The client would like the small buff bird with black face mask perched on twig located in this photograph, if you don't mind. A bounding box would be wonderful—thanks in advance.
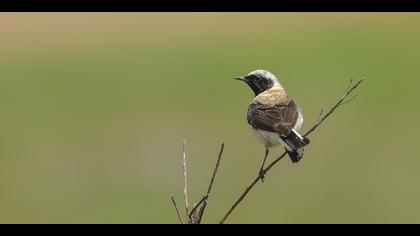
[235,69,310,181]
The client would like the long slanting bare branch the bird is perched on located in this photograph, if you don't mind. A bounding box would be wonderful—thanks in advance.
[219,79,364,224]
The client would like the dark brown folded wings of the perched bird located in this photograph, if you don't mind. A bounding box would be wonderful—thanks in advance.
[247,99,299,137]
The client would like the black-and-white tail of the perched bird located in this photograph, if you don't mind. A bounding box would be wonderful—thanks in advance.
[283,129,310,163]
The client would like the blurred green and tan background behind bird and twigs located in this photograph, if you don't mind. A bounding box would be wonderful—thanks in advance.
[0,13,420,223]
